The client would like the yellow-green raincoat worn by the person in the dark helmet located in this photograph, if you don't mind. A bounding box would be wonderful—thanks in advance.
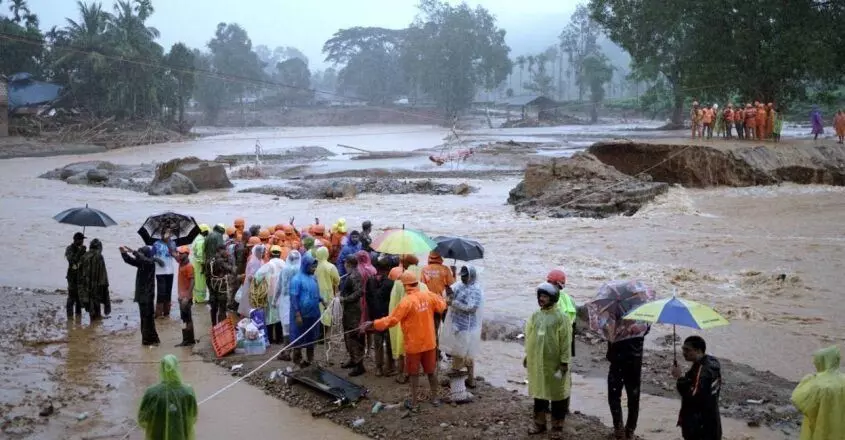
[525,306,572,401]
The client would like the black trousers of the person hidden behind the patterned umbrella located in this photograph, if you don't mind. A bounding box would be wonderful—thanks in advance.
[607,358,643,432]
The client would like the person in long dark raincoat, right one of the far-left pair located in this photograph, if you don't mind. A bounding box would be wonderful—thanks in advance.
[79,238,111,321]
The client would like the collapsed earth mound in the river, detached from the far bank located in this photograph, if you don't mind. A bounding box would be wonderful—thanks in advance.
[508,153,669,218]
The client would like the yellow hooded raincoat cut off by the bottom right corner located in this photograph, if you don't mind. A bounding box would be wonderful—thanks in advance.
[792,346,845,440]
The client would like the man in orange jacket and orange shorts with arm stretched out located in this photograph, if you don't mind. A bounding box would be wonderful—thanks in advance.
[363,271,446,410]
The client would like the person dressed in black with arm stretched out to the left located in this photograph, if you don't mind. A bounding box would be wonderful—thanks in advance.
[121,246,161,345]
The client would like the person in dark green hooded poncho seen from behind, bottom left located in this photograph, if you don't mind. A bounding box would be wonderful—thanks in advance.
[138,354,198,440]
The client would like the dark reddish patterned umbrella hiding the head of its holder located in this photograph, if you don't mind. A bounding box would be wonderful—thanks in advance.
[586,280,654,343]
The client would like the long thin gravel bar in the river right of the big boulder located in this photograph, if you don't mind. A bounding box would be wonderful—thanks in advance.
[239,178,478,200]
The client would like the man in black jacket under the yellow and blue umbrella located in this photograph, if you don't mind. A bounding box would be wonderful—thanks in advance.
[672,336,724,440]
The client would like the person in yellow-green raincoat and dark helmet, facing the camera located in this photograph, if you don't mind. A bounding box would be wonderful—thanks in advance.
[523,283,572,435]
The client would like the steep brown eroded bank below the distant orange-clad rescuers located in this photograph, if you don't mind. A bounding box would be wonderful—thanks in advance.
[587,141,845,188]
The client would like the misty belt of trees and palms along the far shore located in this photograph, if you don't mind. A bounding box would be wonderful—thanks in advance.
[0,0,845,124]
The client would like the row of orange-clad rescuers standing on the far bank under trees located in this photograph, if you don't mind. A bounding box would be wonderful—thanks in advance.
[690,101,783,142]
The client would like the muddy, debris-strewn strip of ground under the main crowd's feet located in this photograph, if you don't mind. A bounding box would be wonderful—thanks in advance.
[195,336,610,440]
